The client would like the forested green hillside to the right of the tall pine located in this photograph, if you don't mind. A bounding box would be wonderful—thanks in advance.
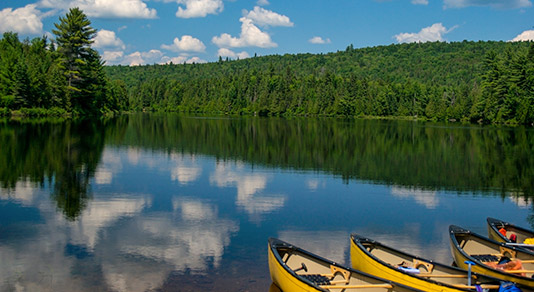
[105,41,534,124]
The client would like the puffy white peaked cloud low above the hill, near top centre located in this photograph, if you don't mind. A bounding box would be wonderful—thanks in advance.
[211,17,278,48]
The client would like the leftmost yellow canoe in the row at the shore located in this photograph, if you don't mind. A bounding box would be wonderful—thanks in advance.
[269,238,422,292]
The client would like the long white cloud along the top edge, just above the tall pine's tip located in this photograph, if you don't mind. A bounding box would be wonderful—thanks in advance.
[39,0,157,18]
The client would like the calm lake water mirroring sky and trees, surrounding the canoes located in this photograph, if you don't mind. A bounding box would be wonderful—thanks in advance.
[0,115,534,291]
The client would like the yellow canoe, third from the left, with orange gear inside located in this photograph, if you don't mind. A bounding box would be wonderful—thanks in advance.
[449,225,534,287]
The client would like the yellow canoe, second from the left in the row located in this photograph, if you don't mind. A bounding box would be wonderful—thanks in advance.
[350,234,506,292]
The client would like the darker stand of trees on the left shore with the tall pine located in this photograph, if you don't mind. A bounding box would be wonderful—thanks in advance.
[0,8,124,116]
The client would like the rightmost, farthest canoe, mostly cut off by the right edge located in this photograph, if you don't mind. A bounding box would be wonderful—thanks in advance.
[486,217,534,249]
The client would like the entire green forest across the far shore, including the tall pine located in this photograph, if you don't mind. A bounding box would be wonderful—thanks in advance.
[0,8,534,125]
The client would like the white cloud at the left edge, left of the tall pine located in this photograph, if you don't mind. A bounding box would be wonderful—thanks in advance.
[0,4,43,34]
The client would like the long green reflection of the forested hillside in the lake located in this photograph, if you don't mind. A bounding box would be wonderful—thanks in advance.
[117,115,534,198]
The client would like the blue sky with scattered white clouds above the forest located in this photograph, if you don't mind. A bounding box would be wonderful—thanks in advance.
[0,0,534,65]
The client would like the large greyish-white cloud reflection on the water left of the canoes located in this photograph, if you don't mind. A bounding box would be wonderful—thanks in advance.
[103,197,239,291]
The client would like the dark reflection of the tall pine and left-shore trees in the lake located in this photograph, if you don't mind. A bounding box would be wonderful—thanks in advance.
[0,117,128,220]
